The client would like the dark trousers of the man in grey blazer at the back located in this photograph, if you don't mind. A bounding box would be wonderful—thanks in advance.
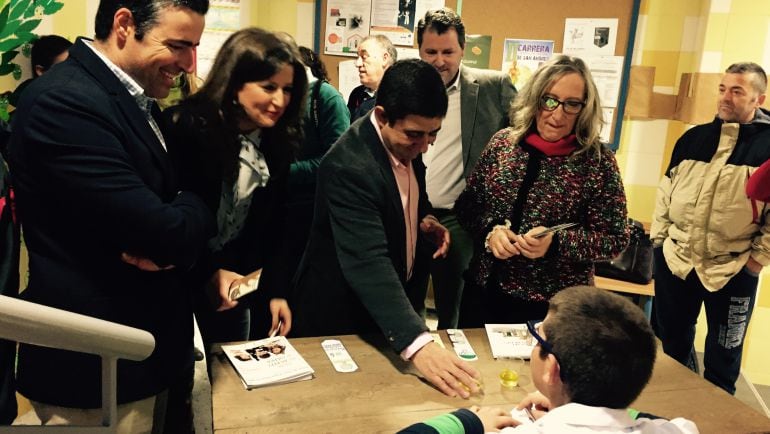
[430,210,473,330]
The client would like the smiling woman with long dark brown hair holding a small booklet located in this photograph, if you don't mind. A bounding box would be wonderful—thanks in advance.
[164,28,307,347]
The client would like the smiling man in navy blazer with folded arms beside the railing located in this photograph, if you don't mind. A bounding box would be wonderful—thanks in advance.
[9,0,214,430]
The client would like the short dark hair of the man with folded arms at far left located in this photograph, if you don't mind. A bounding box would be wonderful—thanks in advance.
[94,0,209,41]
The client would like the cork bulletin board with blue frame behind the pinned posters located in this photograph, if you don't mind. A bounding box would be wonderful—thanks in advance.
[315,0,641,149]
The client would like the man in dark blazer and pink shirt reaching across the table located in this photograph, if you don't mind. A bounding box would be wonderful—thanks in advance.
[292,59,478,397]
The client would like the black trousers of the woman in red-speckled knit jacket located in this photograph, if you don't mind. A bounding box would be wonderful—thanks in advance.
[458,282,548,328]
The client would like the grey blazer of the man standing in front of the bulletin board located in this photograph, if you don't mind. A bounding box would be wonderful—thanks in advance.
[456,66,516,178]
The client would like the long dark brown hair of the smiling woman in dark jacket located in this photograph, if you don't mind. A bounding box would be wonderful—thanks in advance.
[184,27,307,179]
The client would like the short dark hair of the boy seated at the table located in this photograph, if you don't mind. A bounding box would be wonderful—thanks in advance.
[540,286,657,408]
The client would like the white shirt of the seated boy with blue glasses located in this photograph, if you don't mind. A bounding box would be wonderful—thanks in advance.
[500,403,698,434]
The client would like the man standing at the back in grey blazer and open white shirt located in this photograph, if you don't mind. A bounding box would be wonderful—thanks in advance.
[417,8,516,329]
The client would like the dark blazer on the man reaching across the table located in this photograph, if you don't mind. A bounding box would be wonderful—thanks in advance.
[291,116,435,352]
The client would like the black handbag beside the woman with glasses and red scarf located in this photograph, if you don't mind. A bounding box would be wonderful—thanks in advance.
[594,219,652,285]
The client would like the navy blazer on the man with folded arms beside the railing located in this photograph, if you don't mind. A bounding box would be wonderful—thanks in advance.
[9,40,214,408]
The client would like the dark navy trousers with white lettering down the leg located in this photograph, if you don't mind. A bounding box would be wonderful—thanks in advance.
[653,248,758,394]
